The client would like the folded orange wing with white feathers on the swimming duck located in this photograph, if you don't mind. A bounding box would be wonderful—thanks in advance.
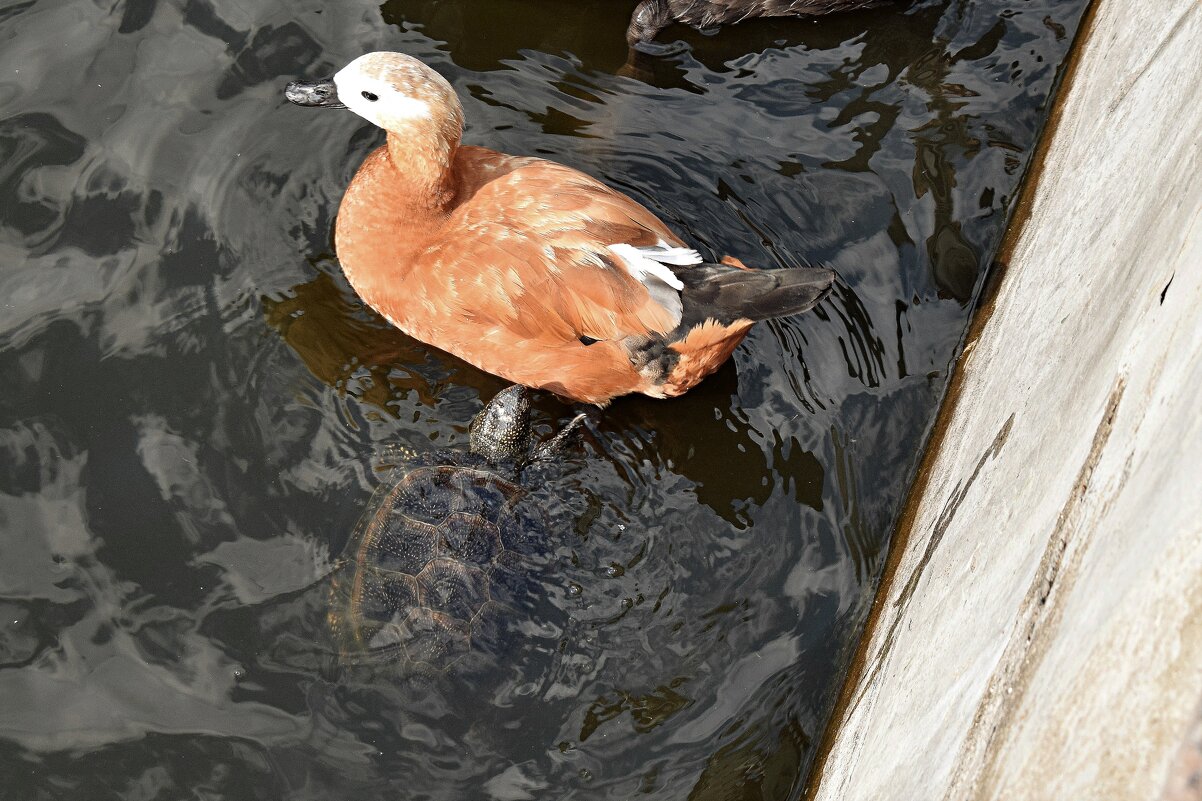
[422,159,701,340]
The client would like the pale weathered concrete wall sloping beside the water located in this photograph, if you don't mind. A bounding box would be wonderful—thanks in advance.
[810,0,1202,801]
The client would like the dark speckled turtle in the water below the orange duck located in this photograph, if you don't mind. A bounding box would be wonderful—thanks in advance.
[329,386,584,671]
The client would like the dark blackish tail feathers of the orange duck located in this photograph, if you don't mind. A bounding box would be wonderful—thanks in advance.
[670,265,835,327]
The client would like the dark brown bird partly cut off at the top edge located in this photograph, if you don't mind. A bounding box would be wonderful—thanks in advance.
[626,0,887,47]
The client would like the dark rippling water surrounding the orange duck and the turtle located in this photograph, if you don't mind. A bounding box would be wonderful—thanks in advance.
[0,0,1084,800]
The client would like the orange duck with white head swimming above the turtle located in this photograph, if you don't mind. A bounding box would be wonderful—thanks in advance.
[287,53,834,404]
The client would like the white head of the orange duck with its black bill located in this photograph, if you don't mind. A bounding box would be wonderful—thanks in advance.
[285,52,463,143]
